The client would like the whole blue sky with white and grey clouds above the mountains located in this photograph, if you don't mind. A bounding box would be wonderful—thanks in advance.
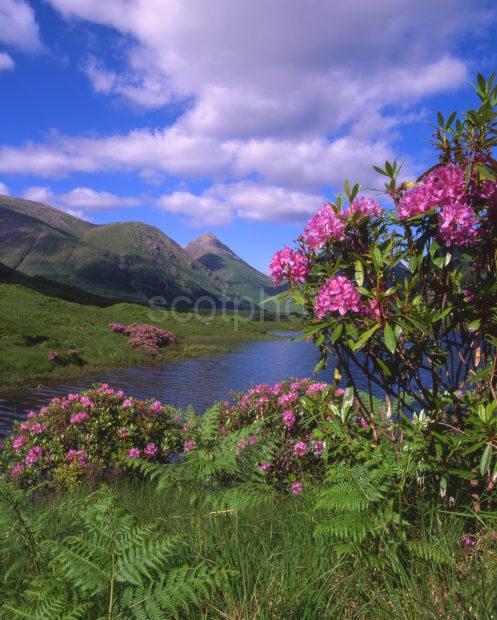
[0,0,497,272]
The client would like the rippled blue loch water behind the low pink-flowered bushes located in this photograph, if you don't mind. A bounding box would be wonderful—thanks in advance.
[0,332,384,436]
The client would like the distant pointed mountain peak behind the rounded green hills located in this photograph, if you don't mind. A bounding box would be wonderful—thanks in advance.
[185,233,276,303]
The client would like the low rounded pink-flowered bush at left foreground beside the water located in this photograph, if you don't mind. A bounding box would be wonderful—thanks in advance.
[1,384,184,486]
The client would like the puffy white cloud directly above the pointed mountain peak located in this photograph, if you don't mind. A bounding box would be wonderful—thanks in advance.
[157,182,324,226]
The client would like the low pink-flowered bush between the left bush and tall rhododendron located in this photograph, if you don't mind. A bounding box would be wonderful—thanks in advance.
[207,379,354,495]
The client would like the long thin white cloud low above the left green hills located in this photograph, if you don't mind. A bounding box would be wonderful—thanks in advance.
[23,186,142,217]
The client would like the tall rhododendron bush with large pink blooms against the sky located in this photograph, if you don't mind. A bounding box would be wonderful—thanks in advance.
[270,75,497,419]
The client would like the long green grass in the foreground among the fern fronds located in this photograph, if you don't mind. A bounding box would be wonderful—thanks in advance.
[0,480,497,620]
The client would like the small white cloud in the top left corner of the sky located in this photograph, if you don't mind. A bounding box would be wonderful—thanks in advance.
[0,0,42,52]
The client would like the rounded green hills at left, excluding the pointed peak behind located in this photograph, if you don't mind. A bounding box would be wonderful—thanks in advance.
[0,196,222,303]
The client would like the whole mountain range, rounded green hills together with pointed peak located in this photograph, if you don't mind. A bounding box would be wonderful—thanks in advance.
[0,196,278,307]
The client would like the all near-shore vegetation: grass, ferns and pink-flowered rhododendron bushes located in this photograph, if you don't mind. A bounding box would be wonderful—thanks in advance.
[0,76,497,620]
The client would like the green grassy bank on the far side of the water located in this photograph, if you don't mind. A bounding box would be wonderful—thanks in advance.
[0,283,298,393]
